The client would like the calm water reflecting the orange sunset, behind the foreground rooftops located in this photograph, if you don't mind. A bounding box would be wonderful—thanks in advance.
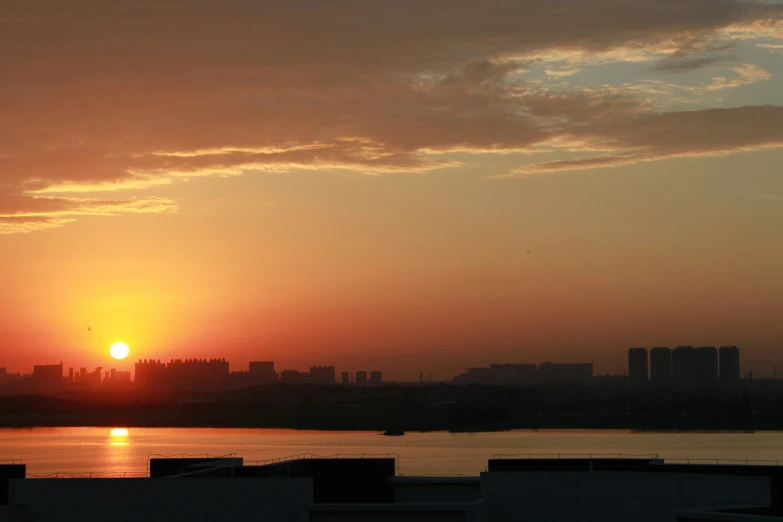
[0,428,783,476]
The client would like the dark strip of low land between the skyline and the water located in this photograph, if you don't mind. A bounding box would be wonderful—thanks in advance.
[0,385,783,433]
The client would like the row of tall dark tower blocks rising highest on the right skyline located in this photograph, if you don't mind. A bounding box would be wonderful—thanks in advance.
[628,346,740,388]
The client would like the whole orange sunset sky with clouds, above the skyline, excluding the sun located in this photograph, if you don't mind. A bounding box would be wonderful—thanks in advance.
[0,0,783,379]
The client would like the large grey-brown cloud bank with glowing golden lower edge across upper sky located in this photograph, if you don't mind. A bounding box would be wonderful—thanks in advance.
[0,0,783,231]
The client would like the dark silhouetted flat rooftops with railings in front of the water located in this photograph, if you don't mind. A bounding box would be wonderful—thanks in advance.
[0,456,783,522]
